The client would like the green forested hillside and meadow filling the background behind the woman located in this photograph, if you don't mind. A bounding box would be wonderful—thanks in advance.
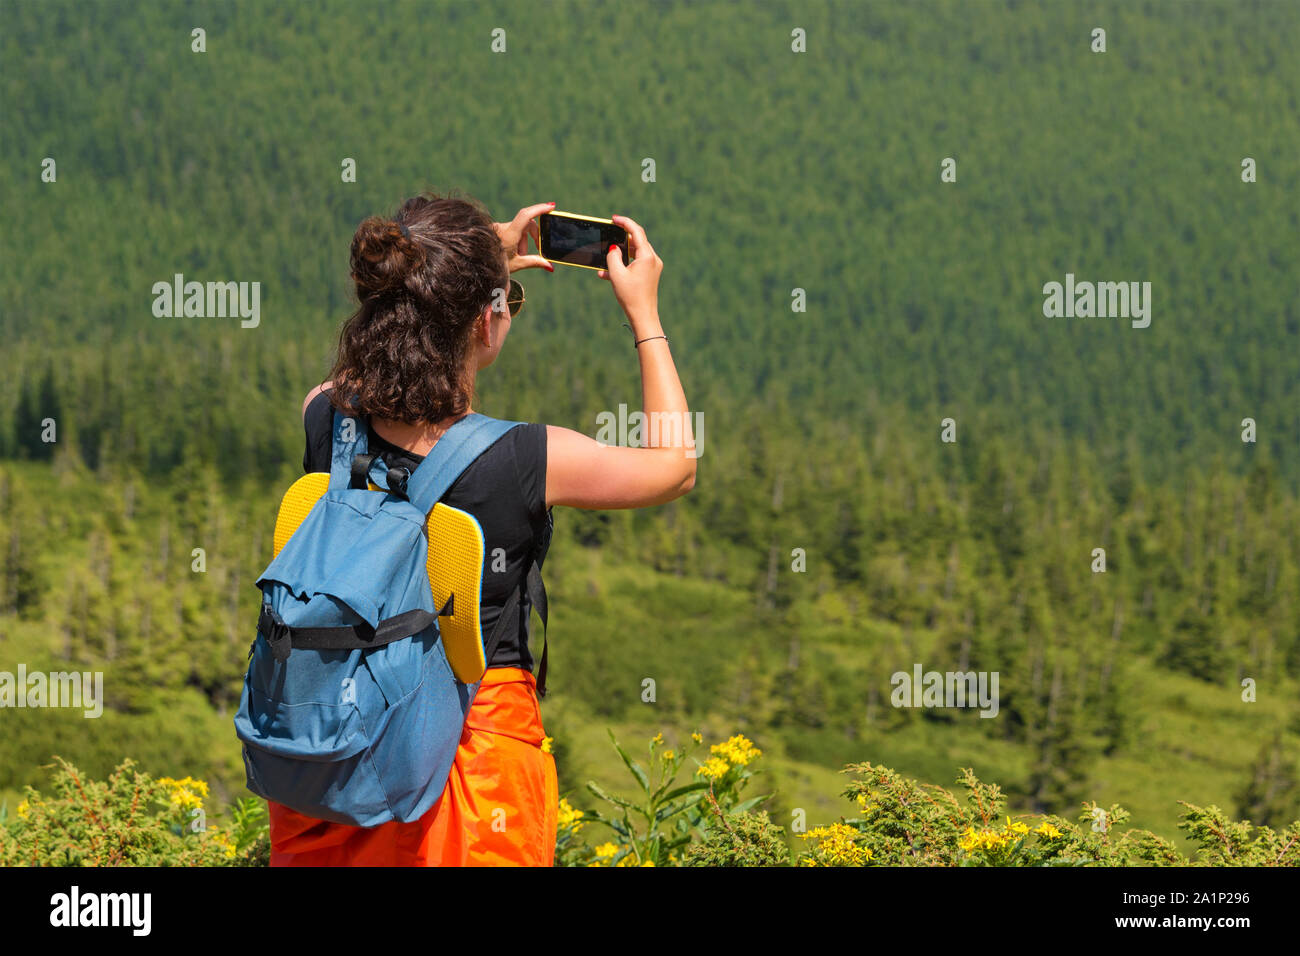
[0,0,1300,852]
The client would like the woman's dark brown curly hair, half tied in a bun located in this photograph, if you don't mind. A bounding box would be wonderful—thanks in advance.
[330,194,510,424]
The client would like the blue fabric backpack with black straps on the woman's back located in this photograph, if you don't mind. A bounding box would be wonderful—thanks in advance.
[234,411,546,827]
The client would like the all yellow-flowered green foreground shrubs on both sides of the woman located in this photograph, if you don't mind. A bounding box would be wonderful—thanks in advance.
[12,734,1300,866]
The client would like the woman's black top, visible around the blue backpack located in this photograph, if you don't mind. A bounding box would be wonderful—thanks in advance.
[303,390,551,670]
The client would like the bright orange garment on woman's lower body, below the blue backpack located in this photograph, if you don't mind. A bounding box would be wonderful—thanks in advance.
[268,667,559,866]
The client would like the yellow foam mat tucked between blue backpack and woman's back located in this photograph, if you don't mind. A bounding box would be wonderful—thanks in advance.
[273,472,488,684]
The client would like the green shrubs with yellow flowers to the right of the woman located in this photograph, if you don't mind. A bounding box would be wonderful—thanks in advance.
[556,735,1300,866]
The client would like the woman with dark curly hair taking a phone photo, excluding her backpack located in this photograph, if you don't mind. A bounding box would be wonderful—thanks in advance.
[263,195,696,866]
